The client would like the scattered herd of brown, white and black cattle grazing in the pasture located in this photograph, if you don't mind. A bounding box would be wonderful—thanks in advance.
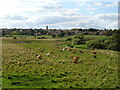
[15,42,97,65]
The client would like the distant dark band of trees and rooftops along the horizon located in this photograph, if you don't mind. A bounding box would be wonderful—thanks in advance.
[2,28,117,37]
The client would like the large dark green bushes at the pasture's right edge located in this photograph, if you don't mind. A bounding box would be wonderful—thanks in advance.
[86,36,118,51]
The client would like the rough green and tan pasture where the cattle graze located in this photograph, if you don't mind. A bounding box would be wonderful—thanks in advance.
[2,39,119,88]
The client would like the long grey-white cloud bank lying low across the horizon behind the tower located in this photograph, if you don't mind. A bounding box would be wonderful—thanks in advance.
[0,13,117,29]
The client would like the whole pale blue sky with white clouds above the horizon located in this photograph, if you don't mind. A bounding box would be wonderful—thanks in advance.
[0,0,118,29]
